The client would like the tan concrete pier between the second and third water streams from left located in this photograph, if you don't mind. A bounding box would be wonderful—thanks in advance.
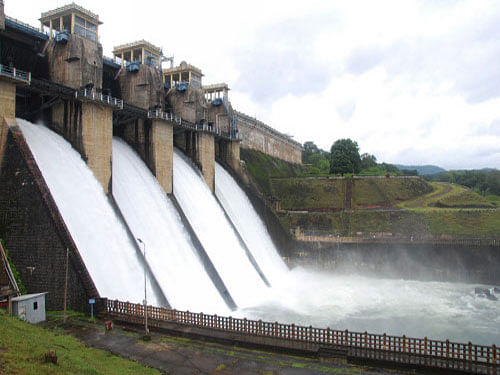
[151,119,174,194]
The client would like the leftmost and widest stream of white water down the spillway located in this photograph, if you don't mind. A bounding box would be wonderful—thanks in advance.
[17,119,158,305]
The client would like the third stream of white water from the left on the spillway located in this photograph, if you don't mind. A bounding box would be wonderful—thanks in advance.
[174,150,268,307]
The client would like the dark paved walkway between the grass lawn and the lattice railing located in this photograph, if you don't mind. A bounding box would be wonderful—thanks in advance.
[44,318,409,375]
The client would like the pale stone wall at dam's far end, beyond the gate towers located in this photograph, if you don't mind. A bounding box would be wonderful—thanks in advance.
[235,111,302,164]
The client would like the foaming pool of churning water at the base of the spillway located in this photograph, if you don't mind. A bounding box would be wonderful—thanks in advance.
[237,268,500,345]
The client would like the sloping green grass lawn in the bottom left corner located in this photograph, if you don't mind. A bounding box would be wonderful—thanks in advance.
[0,310,160,375]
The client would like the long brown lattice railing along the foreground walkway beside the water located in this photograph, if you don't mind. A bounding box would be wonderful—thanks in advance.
[103,299,500,367]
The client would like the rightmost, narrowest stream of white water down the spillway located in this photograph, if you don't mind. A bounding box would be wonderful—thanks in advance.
[215,163,288,286]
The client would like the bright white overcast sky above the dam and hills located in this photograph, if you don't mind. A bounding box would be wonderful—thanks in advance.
[4,0,500,169]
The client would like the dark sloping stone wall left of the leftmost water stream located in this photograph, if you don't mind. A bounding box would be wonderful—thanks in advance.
[0,127,99,311]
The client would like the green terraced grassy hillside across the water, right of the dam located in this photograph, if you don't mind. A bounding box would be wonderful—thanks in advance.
[238,149,500,238]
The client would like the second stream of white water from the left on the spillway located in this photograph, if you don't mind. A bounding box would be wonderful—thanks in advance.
[113,138,228,314]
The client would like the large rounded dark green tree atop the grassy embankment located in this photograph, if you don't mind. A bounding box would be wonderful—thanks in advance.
[330,138,361,174]
